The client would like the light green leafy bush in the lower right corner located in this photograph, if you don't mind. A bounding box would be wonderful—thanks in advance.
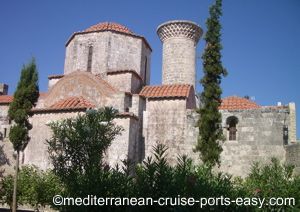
[243,158,300,211]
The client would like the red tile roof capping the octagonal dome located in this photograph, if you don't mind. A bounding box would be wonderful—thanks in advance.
[84,22,134,35]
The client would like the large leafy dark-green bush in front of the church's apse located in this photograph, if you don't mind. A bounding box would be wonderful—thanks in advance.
[47,107,122,211]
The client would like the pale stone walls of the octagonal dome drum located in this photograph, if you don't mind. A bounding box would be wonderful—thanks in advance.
[64,31,151,82]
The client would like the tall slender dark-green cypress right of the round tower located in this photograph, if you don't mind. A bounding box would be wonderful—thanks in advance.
[195,0,227,165]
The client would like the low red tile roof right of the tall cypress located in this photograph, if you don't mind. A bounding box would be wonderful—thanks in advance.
[219,96,261,110]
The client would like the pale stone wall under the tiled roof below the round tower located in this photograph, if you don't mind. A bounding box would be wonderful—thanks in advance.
[143,99,197,164]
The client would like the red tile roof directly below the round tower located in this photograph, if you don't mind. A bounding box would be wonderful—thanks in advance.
[140,84,192,98]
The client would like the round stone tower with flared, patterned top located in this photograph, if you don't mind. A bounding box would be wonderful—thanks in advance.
[157,20,203,87]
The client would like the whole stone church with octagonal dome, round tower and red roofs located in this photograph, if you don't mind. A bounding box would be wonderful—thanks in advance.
[0,20,300,176]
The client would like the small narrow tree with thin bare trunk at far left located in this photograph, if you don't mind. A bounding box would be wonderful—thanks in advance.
[8,59,39,211]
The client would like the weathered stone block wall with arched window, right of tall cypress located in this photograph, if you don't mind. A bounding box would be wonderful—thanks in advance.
[220,108,288,176]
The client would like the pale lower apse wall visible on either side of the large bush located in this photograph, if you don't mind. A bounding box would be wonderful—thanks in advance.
[21,112,137,169]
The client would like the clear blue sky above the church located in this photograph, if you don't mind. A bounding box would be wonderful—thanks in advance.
[0,0,300,138]
